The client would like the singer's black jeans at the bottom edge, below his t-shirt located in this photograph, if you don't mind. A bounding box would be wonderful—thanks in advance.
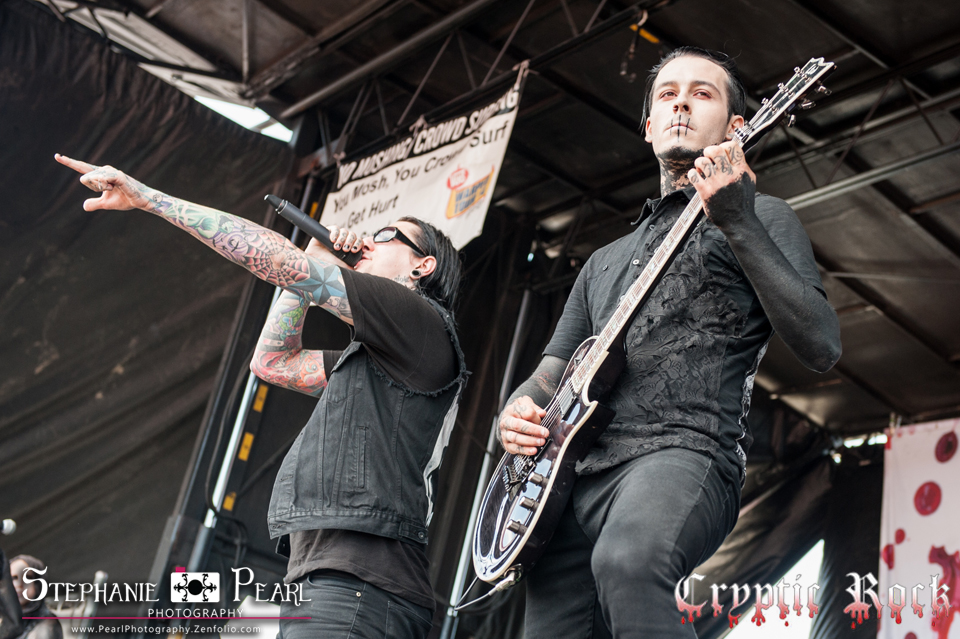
[277,570,433,639]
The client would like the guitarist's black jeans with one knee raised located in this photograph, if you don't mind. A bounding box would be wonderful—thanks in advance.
[525,448,740,639]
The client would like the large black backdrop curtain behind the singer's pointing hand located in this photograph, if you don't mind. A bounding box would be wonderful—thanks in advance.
[0,0,292,582]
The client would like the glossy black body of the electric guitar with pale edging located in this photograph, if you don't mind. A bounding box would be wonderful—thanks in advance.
[473,337,625,582]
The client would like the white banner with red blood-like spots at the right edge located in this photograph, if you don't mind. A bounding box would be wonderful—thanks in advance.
[876,419,960,639]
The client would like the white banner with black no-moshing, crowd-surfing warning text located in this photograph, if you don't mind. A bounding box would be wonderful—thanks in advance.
[320,64,527,249]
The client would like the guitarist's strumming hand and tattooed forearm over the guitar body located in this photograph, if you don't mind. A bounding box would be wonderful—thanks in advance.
[497,355,567,455]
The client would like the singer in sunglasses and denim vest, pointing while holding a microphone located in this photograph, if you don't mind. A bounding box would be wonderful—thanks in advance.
[56,155,467,639]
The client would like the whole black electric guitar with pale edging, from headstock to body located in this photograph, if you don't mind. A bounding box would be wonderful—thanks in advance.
[472,58,834,590]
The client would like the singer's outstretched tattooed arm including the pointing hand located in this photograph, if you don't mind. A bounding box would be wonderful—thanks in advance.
[56,155,353,324]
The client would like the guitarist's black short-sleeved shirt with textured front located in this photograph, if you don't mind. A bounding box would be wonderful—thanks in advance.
[544,188,823,488]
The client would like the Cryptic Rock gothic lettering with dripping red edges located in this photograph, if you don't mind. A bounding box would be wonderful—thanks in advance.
[673,572,951,636]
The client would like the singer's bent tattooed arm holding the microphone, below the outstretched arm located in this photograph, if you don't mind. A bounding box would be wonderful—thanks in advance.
[250,291,327,396]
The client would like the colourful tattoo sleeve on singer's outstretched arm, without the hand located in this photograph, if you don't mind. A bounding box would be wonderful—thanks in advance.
[137,188,353,324]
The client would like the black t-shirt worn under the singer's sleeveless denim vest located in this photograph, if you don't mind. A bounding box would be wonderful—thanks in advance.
[284,269,458,609]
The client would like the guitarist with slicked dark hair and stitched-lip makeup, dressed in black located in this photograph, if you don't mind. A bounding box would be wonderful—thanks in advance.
[498,47,840,639]
